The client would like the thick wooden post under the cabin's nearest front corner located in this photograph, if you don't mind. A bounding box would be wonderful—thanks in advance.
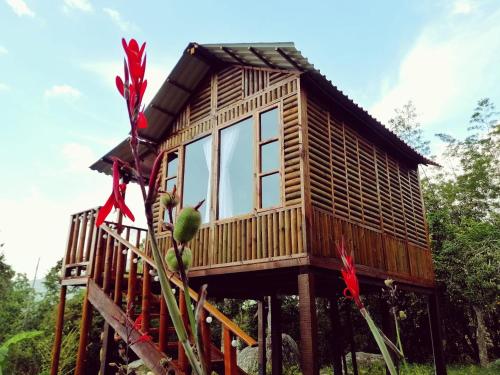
[298,272,319,375]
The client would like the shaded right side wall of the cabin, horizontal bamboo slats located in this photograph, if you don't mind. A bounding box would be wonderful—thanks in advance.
[306,93,433,280]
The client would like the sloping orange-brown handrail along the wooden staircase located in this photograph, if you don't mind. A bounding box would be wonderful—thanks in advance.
[100,224,257,346]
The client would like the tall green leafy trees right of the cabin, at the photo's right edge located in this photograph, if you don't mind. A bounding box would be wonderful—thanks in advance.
[423,99,500,365]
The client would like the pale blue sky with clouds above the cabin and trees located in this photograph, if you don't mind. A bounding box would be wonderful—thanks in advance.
[0,0,500,277]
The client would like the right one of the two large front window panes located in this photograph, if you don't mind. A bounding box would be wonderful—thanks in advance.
[218,118,254,219]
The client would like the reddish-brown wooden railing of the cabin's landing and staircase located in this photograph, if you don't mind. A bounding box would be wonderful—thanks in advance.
[62,208,257,374]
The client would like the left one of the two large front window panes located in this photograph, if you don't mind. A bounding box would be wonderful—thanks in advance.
[182,136,212,223]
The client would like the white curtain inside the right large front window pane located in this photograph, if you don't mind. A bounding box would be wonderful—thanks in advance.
[219,125,241,219]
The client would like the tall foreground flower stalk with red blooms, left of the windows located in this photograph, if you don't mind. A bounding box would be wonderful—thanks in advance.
[96,39,207,375]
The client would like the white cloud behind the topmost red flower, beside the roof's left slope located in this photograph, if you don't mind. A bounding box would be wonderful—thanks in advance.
[82,57,174,104]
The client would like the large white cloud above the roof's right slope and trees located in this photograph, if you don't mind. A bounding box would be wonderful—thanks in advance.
[371,5,500,130]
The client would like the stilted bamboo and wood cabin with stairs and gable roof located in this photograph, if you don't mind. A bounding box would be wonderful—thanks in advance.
[52,43,446,374]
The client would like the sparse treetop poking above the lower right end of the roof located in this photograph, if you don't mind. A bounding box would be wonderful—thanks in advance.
[389,100,431,156]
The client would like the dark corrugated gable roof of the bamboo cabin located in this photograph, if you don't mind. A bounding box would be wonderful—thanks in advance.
[90,42,435,174]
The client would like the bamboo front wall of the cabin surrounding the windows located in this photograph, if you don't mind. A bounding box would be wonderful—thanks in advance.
[150,67,305,268]
